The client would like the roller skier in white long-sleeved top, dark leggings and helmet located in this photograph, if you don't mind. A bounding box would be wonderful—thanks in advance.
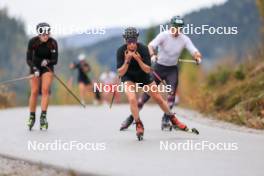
[120,16,202,130]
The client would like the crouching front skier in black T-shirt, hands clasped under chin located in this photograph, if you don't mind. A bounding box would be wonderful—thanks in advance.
[116,27,198,140]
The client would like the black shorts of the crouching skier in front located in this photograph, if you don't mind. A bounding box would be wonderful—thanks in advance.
[121,74,154,86]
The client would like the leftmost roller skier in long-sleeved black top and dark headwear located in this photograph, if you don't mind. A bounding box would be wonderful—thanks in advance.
[27,23,58,130]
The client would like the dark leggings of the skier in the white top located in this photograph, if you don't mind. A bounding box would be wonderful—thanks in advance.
[138,63,178,109]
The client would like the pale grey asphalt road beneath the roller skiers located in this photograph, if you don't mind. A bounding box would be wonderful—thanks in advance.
[0,105,264,176]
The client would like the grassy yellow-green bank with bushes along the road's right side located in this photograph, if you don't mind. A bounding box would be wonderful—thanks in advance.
[179,47,264,129]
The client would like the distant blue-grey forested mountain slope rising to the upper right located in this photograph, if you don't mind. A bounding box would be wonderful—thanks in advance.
[61,0,260,69]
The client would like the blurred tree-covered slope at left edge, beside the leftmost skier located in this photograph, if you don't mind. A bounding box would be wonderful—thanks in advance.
[0,9,28,108]
